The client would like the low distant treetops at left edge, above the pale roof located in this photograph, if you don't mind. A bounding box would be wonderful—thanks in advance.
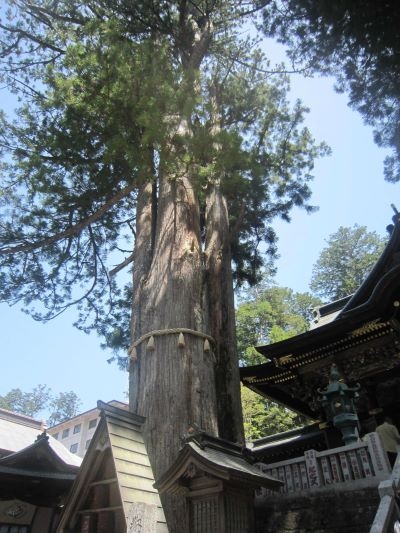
[0,385,82,425]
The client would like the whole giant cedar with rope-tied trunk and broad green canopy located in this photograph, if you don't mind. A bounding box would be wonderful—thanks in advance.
[0,0,325,533]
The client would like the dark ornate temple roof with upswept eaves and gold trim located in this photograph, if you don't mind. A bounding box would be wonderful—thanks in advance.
[240,212,400,418]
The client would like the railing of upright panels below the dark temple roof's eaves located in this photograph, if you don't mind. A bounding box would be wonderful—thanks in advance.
[256,433,391,500]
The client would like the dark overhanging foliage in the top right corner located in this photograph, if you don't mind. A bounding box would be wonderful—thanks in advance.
[263,0,400,182]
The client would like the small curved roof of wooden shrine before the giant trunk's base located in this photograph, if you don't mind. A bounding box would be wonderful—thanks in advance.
[155,433,281,495]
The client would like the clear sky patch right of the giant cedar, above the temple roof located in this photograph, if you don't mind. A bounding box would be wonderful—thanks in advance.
[275,71,394,291]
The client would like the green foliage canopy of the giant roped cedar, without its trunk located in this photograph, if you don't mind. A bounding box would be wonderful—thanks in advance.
[0,0,326,360]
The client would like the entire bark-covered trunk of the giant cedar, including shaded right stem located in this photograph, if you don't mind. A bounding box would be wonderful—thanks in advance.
[130,9,244,533]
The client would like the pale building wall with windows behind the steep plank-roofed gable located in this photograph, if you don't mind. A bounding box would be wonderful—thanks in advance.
[47,400,128,457]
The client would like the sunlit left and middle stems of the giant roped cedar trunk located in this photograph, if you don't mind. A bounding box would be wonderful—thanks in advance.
[130,167,218,533]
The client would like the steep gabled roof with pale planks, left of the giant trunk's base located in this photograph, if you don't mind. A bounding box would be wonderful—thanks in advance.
[57,402,167,533]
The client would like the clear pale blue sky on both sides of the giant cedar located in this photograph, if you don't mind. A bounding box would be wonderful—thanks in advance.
[0,41,400,420]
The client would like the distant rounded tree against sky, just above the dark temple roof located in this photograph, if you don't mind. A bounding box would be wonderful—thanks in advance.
[310,224,386,301]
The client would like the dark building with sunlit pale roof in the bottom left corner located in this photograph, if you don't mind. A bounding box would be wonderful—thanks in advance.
[0,409,81,533]
